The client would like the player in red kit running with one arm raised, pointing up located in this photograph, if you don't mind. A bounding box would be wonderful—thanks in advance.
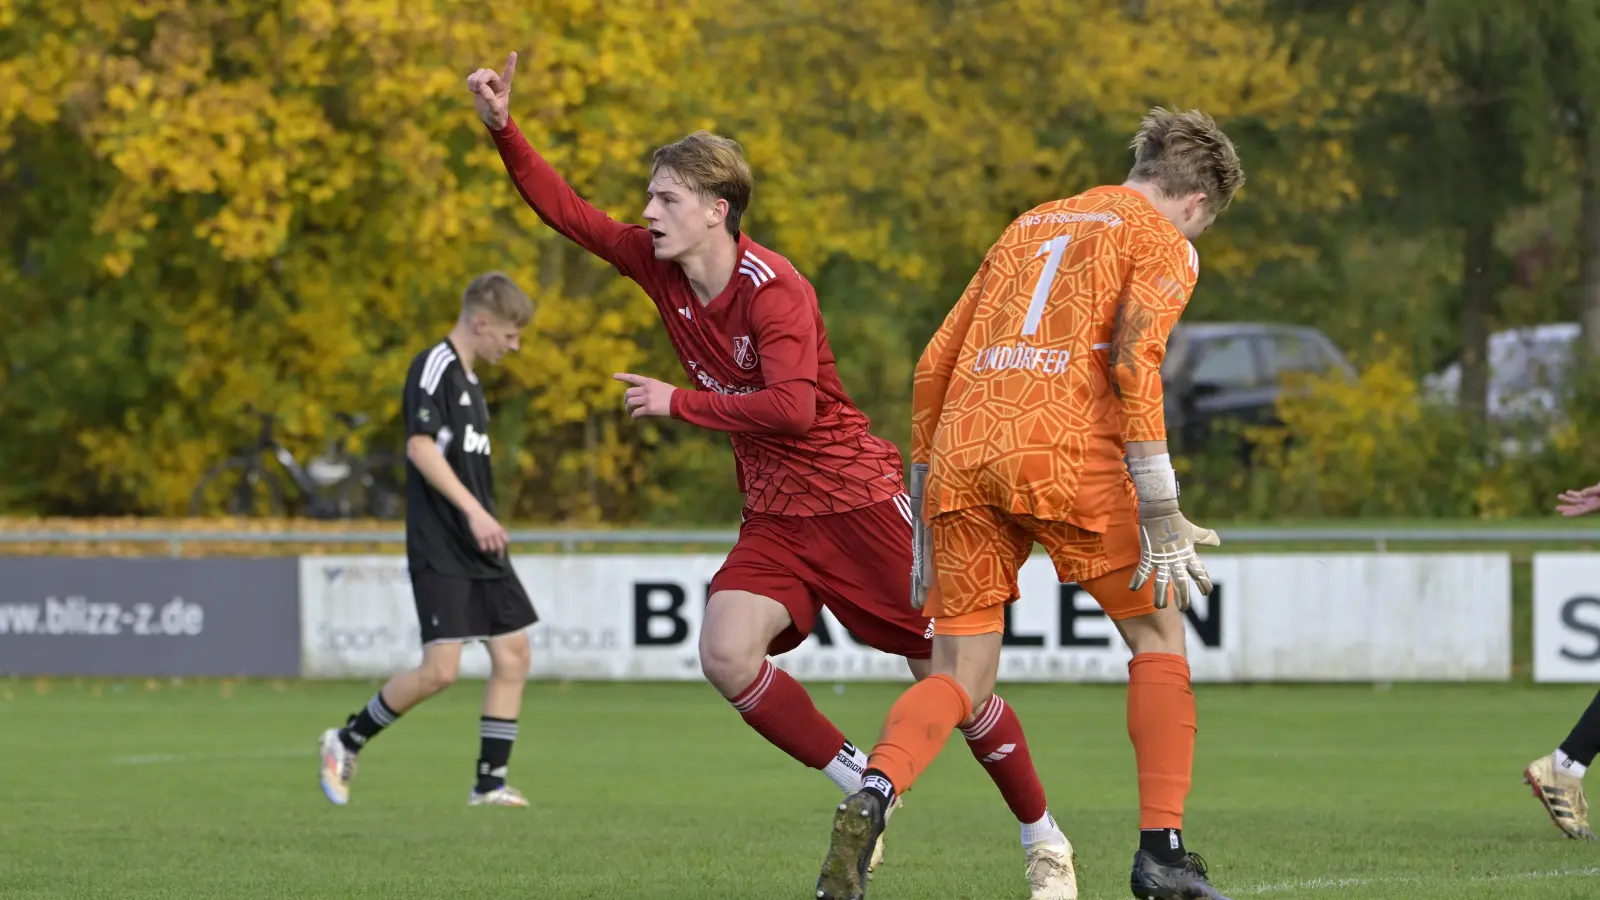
[467,53,1077,900]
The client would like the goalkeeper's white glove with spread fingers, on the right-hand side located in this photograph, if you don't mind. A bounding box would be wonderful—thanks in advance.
[1128,453,1222,610]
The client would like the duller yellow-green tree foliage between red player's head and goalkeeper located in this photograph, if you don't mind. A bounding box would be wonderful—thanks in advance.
[636,0,1371,506]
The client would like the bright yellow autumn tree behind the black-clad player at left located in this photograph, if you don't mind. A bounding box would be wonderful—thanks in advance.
[0,0,716,516]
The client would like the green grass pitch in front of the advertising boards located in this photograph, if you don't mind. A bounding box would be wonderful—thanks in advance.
[0,679,1600,900]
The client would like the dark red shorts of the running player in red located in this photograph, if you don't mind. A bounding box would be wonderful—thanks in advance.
[710,495,933,660]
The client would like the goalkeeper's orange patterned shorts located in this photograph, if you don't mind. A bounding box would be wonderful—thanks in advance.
[922,504,1155,634]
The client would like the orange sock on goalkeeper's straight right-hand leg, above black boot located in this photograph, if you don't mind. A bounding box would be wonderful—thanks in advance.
[1128,653,1195,831]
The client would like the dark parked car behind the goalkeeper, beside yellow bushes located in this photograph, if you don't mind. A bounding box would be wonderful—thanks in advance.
[1162,322,1355,452]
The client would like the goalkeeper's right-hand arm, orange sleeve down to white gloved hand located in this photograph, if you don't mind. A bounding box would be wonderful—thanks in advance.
[1110,240,1222,609]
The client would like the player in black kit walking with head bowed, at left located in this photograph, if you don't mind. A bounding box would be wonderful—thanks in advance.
[322,272,539,807]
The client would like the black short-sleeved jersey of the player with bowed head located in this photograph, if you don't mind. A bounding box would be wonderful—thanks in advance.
[402,338,512,578]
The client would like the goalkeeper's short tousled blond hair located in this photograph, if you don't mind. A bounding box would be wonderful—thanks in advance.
[1128,106,1245,213]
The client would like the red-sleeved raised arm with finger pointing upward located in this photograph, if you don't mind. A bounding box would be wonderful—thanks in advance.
[467,53,654,277]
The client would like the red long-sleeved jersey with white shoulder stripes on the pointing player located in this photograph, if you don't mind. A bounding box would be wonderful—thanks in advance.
[490,120,904,516]
